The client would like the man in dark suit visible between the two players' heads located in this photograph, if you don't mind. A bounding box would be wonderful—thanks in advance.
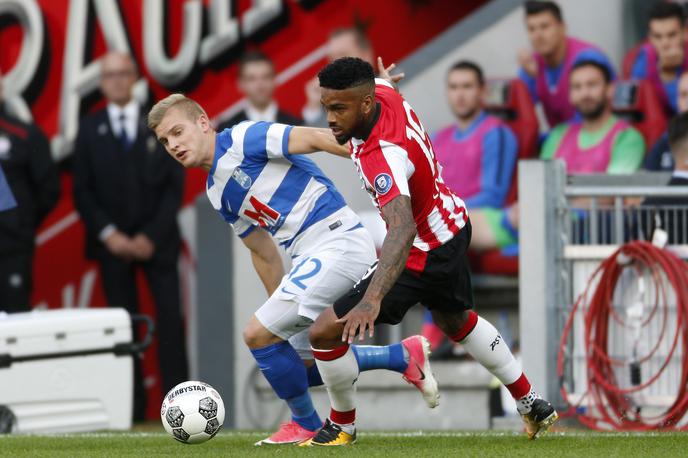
[218,51,303,132]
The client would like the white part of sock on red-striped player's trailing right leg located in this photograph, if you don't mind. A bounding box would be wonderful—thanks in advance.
[456,317,523,385]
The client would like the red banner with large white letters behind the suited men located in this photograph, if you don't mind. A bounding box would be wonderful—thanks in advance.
[0,0,486,415]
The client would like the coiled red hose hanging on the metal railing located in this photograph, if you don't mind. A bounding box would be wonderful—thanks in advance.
[557,241,688,431]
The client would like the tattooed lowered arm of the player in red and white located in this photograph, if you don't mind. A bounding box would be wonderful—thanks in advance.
[337,195,416,343]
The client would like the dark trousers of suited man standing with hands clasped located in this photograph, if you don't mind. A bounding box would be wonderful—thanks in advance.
[99,252,188,418]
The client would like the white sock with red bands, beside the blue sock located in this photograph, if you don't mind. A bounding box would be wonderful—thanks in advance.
[313,345,358,424]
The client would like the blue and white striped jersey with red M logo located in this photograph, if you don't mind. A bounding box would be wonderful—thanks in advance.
[206,121,346,249]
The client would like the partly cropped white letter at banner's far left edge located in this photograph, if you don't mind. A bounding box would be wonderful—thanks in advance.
[0,0,44,122]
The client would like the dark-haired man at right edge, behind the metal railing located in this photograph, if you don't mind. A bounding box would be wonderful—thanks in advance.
[641,112,688,245]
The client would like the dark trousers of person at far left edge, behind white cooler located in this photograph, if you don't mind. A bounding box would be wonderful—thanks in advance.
[0,253,33,313]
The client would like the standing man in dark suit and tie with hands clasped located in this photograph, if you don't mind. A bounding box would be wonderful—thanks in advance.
[74,53,187,418]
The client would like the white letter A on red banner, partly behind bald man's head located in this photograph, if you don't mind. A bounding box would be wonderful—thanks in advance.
[53,0,147,159]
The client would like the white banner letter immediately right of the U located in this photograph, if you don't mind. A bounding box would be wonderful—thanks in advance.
[199,0,239,65]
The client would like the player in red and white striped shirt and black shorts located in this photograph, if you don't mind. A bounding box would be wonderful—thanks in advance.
[303,57,557,445]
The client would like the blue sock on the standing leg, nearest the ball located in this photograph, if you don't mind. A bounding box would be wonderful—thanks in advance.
[251,342,322,431]
